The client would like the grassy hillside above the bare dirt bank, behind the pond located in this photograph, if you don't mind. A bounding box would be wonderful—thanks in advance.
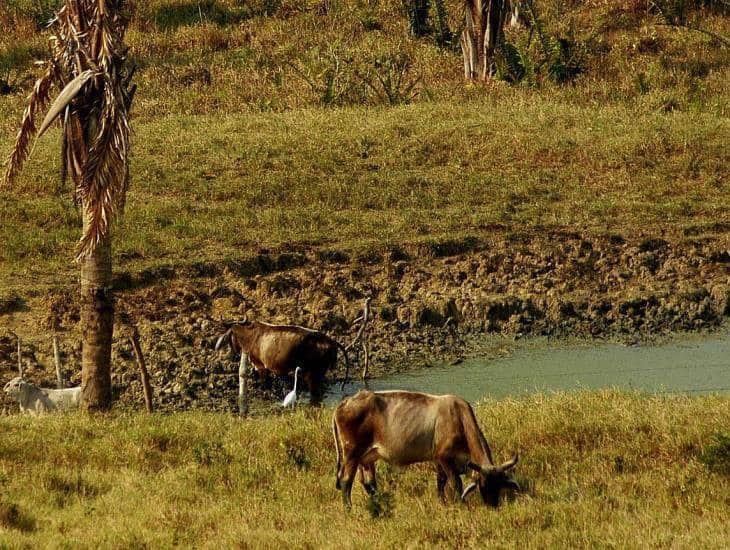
[0,0,730,294]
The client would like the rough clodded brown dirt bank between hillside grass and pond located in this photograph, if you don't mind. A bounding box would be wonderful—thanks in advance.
[0,234,730,410]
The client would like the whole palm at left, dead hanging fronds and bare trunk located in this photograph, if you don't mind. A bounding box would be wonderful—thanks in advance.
[5,0,135,410]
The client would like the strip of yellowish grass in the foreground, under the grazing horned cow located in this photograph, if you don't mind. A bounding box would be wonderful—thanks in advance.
[0,392,730,548]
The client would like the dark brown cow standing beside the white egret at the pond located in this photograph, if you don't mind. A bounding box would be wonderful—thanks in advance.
[215,319,349,404]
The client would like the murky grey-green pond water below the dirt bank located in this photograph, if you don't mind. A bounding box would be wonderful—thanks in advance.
[326,331,730,404]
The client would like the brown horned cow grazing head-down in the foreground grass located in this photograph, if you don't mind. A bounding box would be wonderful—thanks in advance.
[332,390,519,508]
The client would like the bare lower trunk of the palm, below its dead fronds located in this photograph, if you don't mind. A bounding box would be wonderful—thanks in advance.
[81,204,114,411]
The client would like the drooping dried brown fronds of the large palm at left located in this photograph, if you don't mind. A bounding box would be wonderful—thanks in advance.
[5,0,135,259]
